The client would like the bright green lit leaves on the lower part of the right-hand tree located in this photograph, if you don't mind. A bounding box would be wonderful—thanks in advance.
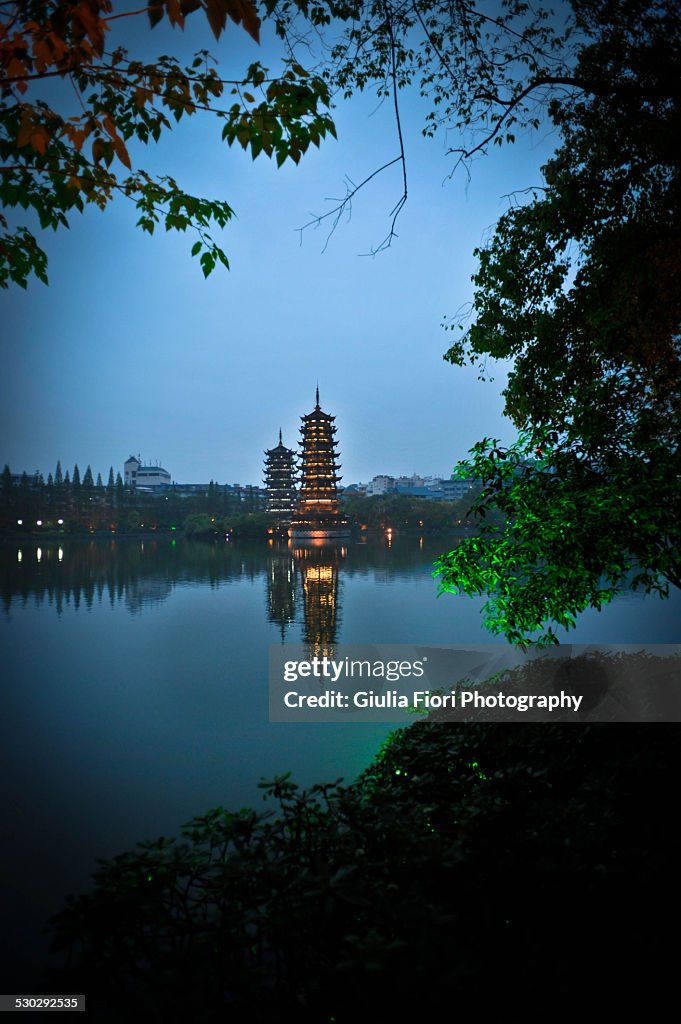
[434,432,681,646]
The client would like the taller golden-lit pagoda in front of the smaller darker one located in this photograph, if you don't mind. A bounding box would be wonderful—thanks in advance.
[291,387,350,542]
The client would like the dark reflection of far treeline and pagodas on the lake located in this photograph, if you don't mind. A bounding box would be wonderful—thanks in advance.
[0,538,438,622]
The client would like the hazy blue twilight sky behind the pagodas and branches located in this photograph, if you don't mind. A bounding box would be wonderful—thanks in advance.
[0,7,555,483]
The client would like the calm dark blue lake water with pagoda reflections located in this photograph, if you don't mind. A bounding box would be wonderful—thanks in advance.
[0,538,681,978]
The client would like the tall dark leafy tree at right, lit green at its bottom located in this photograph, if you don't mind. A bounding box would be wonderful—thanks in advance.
[438,0,681,642]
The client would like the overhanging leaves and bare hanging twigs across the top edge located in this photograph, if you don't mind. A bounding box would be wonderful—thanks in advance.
[0,0,622,287]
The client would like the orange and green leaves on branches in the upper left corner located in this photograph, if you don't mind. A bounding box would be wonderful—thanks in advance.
[0,0,334,287]
